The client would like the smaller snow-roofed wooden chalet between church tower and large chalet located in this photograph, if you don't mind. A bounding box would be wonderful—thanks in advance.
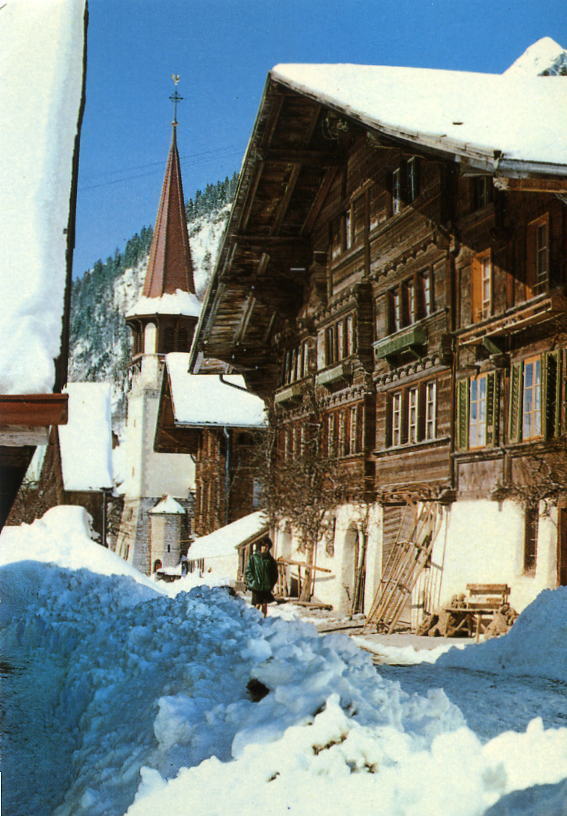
[154,354,266,536]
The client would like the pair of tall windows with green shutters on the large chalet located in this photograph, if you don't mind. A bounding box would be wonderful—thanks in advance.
[456,351,564,450]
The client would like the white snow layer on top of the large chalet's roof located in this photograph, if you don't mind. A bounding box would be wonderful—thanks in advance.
[270,64,567,174]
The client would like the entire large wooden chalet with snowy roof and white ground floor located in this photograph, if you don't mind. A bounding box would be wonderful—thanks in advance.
[192,54,567,626]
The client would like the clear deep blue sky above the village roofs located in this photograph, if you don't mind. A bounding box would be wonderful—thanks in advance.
[74,0,567,274]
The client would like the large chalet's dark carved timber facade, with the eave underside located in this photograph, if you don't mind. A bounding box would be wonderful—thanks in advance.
[193,67,567,604]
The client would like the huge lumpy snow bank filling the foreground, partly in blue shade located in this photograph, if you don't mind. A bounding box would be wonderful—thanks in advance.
[0,508,567,816]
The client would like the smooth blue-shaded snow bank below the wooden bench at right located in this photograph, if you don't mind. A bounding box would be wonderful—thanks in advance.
[437,586,567,682]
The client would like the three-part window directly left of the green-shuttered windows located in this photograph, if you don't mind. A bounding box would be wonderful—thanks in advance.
[386,380,437,447]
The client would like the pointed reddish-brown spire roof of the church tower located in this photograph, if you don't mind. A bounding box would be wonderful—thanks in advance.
[142,131,195,298]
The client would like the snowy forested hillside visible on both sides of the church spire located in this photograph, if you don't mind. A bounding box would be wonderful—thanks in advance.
[69,174,238,425]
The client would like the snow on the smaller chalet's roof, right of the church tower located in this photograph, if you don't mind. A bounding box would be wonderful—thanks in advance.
[166,352,266,428]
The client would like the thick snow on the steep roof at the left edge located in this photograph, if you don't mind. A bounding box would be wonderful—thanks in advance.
[0,0,85,394]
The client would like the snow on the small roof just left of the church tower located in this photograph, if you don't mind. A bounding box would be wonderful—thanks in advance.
[59,383,112,490]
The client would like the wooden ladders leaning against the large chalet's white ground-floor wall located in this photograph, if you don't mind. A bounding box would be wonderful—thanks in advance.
[365,502,439,634]
